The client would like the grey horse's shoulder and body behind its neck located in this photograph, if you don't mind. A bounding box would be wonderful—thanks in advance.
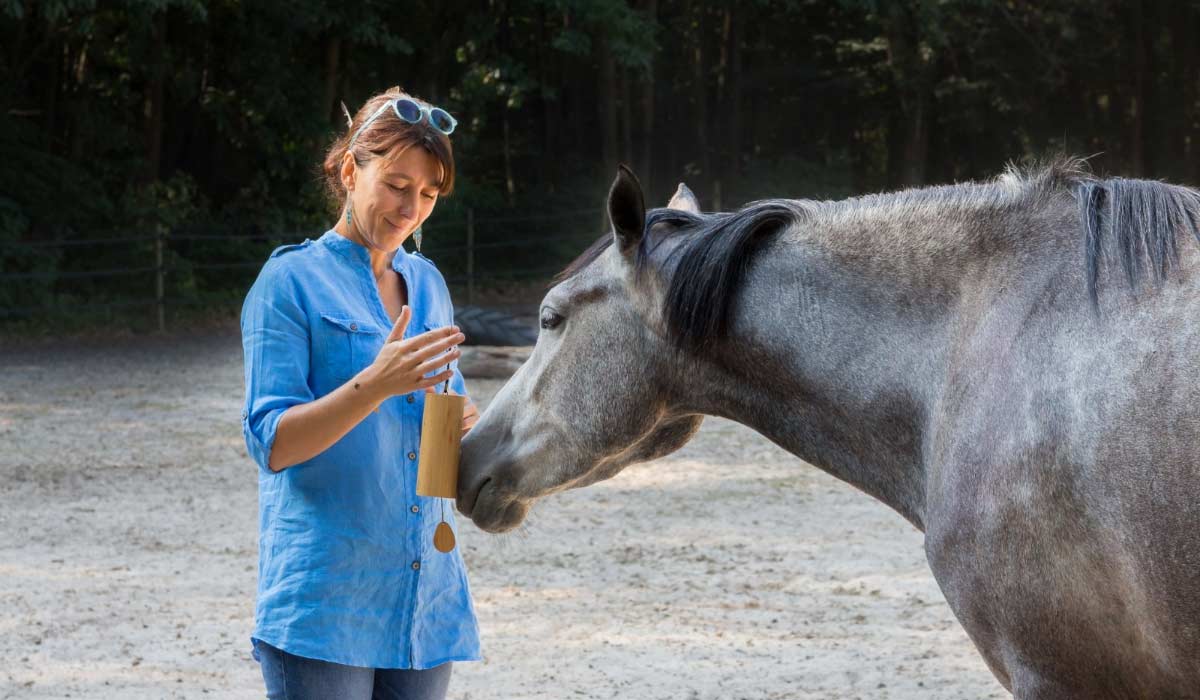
[925,242,1200,698]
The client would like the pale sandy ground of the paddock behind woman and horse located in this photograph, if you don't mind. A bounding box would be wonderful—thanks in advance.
[0,333,1007,700]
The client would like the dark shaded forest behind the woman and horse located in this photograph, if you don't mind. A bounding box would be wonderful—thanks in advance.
[0,0,1200,328]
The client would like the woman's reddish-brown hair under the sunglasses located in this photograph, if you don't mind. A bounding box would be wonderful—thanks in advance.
[322,86,455,211]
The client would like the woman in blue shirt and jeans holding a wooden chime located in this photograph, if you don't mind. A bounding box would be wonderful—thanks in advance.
[241,88,480,700]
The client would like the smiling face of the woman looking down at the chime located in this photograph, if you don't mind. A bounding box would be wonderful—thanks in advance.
[342,145,442,251]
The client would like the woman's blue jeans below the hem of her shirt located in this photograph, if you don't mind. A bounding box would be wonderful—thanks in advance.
[253,639,451,700]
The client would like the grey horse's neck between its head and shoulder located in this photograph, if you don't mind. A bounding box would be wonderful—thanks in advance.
[685,207,1022,530]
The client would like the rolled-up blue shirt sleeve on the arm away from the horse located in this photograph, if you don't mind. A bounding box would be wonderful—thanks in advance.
[241,259,313,474]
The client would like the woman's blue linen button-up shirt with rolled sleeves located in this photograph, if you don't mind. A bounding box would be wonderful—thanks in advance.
[241,231,480,669]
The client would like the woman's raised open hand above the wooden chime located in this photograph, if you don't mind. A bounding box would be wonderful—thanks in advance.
[368,305,467,397]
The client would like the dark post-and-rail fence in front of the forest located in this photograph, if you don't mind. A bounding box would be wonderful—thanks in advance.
[0,209,602,331]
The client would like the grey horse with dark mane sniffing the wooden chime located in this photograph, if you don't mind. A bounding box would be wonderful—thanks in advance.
[457,161,1200,699]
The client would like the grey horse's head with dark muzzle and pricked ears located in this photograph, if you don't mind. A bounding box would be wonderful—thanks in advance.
[457,167,702,532]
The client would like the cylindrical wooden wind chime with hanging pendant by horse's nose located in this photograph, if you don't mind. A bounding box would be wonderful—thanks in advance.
[416,365,467,552]
